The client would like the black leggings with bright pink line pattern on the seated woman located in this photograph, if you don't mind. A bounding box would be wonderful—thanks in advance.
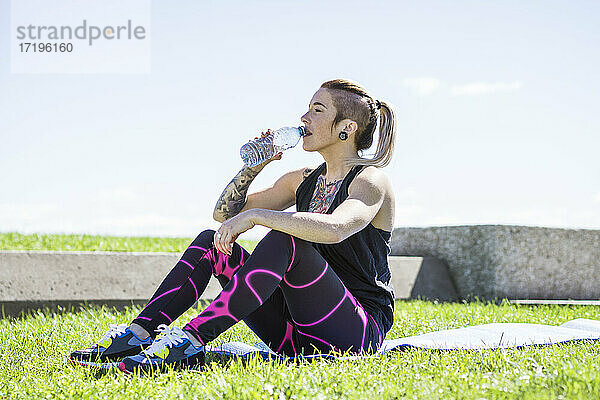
[134,230,383,356]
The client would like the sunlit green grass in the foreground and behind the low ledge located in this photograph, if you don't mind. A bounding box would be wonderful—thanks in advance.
[0,234,600,399]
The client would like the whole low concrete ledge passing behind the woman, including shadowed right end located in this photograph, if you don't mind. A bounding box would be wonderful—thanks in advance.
[0,251,458,315]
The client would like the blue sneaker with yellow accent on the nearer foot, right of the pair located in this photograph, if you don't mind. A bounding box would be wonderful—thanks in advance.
[119,324,204,374]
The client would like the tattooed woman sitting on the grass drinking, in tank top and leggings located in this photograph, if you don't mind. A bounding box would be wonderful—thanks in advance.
[70,79,395,372]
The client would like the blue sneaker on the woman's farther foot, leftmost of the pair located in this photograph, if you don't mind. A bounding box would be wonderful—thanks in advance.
[69,324,152,367]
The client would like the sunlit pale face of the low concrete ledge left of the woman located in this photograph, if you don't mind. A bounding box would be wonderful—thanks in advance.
[0,251,221,301]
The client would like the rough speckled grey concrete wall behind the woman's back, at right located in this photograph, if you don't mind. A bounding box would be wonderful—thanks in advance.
[392,225,600,300]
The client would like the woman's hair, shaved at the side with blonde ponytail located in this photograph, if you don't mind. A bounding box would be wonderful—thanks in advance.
[321,79,396,168]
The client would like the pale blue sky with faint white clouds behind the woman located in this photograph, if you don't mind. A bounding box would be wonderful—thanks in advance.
[0,0,600,238]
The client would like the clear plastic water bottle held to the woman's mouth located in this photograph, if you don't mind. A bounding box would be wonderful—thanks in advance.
[240,126,304,167]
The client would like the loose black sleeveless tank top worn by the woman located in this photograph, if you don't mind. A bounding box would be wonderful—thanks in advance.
[296,163,394,334]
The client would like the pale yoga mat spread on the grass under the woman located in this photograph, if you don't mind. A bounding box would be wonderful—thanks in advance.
[206,318,600,359]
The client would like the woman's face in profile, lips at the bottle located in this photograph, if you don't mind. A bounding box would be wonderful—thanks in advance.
[300,88,337,151]
